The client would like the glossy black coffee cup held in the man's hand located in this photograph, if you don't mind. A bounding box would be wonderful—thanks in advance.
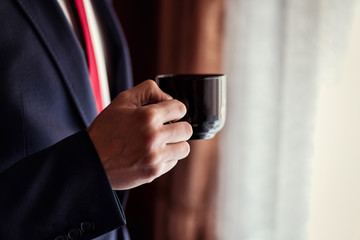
[156,74,226,139]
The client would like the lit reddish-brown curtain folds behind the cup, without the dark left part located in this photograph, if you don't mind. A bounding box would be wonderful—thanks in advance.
[154,0,224,240]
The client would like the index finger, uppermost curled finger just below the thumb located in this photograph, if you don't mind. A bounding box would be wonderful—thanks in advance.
[143,100,187,124]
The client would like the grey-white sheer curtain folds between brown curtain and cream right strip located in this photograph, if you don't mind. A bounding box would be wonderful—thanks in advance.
[218,0,319,240]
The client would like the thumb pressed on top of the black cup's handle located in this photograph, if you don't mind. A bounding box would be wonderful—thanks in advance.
[129,80,173,106]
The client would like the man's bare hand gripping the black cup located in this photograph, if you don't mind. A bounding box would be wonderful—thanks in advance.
[88,80,192,190]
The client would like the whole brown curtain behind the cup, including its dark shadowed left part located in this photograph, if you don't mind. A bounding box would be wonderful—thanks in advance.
[115,0,224,240]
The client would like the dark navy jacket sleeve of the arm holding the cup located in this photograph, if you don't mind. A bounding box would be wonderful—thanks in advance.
[0,131,125,240]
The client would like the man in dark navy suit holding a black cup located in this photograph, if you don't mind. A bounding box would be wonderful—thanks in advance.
[0,0,192,240]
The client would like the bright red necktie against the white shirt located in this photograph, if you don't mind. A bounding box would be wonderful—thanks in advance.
[75,0,103,113]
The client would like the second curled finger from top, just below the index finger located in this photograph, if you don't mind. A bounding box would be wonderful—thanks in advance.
[162,122,193,143]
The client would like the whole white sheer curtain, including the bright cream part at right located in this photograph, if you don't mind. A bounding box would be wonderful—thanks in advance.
[217,0,360,240]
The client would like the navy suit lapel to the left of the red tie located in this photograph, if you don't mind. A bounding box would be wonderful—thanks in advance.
[17,0,97,126]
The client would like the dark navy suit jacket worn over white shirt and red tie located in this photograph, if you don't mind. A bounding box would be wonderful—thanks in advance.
[0,0,132,240]
